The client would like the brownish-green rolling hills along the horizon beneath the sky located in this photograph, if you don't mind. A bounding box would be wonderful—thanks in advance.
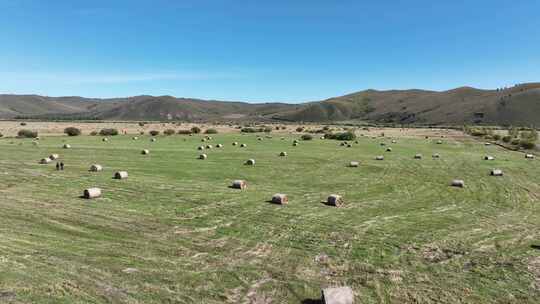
[0,83,540,125]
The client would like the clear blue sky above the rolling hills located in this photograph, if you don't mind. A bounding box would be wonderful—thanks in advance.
[0,0,540,102]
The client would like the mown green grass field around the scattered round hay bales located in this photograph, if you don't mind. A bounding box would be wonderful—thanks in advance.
[0,134,540,304]
